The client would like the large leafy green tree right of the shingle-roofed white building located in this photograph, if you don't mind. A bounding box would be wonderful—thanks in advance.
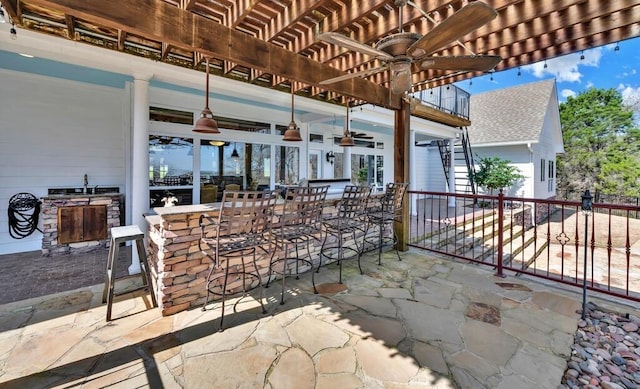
[557,88,640,196]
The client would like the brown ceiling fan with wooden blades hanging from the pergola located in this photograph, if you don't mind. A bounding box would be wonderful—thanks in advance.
[317,0,502,94]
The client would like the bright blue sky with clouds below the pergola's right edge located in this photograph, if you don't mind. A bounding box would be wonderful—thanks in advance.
[456,37,640,113]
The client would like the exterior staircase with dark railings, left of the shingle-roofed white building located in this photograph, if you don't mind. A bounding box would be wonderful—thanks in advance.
[436,127,476,194]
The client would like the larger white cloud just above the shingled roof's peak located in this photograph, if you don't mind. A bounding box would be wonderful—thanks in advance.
[522,47,602,83]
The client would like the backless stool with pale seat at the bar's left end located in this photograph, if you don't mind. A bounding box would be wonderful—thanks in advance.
[102,225,158,321]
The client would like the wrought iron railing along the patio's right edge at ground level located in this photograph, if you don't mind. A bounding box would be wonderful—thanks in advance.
[409,191,640,301]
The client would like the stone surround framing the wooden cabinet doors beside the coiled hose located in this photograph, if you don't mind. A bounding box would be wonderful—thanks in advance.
[41,194,122,256]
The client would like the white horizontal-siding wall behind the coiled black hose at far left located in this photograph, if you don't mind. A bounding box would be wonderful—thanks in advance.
[0,69,129,255]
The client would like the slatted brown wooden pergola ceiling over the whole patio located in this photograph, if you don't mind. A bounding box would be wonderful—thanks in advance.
[0,0,640,109]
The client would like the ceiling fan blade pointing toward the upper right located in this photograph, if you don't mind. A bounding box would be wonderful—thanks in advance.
[407,1,498,57]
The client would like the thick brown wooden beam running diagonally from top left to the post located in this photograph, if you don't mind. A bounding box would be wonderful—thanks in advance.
[26,0,400,109]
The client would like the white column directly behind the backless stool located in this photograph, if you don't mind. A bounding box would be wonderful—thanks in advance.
[129,74,153,274]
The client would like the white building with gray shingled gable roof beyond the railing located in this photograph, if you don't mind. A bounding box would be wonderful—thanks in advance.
[469,79,564,199]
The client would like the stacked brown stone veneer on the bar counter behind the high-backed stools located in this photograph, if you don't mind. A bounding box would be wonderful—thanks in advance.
[147,205,377,316]
